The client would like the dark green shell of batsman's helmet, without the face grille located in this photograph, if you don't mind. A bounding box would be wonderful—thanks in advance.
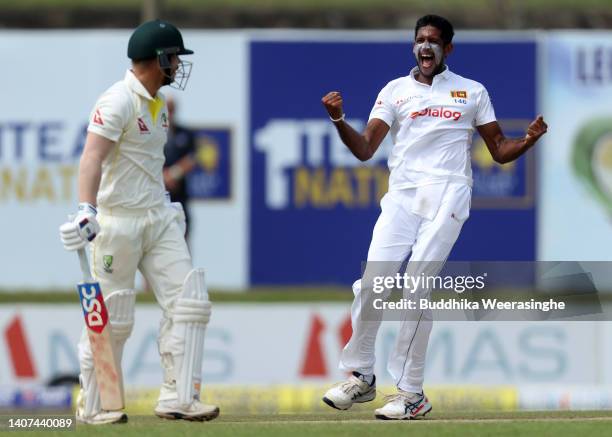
[128,20,193,61]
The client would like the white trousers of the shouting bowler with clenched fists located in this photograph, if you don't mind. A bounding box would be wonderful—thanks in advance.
[340,183,471,393]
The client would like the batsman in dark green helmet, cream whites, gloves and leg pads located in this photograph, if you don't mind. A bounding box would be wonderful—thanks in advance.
[60,20,219,424]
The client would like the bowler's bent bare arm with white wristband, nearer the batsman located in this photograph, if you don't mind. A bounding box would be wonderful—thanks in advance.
[321,91,389,161]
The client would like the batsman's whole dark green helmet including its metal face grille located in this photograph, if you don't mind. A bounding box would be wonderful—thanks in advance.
[128,20,193,90]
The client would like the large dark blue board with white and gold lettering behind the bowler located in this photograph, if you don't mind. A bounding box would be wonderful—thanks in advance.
[250,36,536,285]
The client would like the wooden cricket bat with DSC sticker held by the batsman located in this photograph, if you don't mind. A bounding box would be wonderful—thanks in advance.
[77,248,125,411]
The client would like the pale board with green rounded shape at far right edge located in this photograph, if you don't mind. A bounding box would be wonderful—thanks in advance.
[538,32,612,261]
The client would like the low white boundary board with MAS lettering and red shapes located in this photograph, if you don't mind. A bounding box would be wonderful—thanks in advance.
[0,304,612,387]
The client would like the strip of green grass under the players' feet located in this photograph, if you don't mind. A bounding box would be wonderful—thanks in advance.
[7,411,612,437]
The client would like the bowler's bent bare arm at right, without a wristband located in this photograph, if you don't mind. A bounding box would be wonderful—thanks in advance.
[476,115,548,164]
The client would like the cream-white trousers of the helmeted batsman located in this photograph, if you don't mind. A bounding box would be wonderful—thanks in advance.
[79,206,192,396]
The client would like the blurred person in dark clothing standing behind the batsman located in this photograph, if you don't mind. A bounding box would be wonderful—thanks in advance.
[164,96,196,238]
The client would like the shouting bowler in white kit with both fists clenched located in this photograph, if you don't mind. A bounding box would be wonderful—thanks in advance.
[322,15,547,419]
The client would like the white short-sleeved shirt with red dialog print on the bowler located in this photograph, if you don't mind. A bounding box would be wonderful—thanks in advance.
[370,67,495,190]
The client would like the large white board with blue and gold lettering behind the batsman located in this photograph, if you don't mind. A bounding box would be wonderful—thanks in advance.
[0,30,248,290]
